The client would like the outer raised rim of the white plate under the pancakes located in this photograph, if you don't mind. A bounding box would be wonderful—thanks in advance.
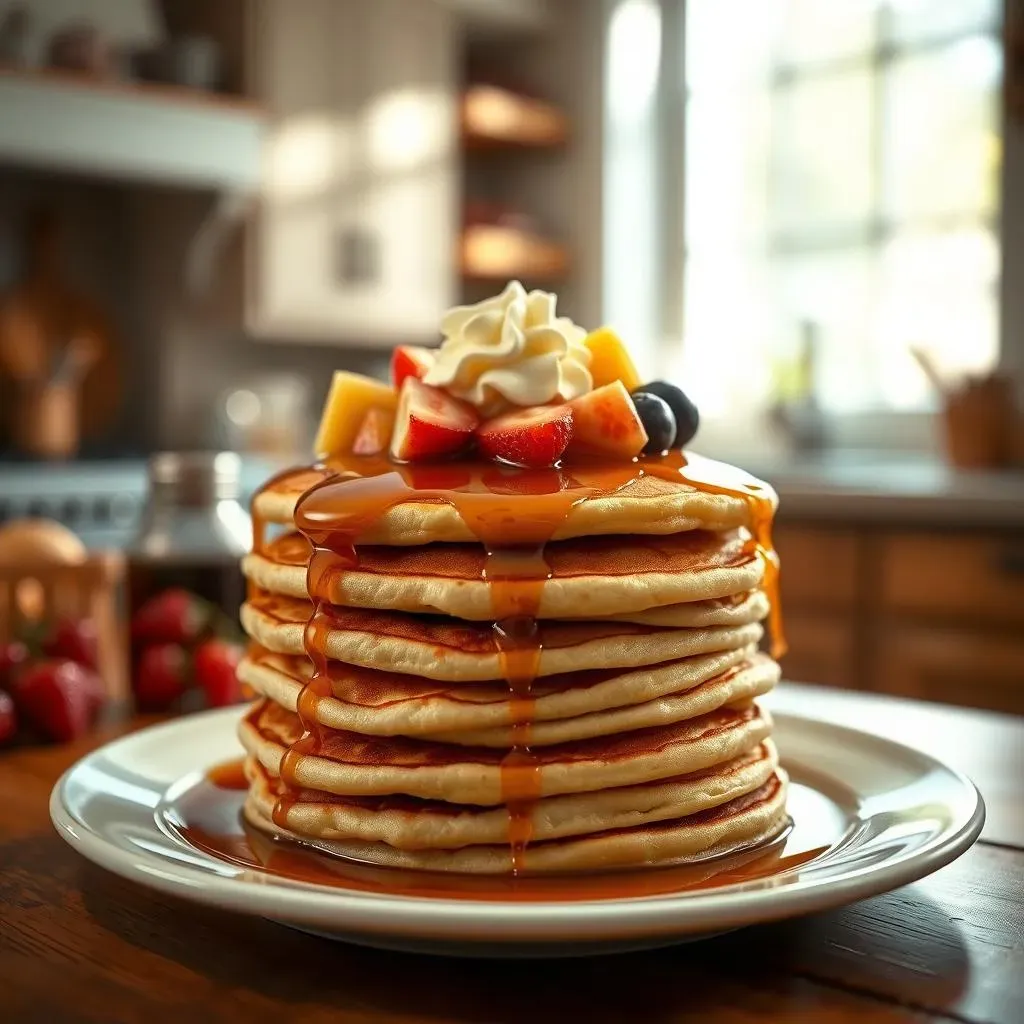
[49,708,985,943]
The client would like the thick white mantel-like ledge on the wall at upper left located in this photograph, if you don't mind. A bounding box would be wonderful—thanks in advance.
[0,67,265,190]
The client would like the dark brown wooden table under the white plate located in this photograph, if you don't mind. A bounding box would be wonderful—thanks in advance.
[0,687,1024,1024]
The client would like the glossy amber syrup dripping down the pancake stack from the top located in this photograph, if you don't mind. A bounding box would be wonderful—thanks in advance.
[254,451,785,876]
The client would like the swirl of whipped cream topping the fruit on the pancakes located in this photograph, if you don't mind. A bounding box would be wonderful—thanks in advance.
[423,281,593,416]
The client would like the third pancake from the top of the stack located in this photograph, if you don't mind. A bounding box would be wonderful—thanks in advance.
[241,594,763,682]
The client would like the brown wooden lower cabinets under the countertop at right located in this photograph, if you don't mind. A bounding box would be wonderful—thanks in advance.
[776,520,1024,714]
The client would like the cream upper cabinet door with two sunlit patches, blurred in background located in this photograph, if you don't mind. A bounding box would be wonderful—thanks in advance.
[246,0,458,344]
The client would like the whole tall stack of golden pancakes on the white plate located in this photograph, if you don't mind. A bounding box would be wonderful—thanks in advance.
[239,462,786,873]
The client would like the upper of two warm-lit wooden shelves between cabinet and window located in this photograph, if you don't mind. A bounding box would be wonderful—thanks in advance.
[461,85,568,152]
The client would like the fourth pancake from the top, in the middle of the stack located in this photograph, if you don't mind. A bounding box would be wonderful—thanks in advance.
[239,647,779,748]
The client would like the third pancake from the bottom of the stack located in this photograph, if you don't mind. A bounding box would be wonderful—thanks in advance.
[239,700,771,806]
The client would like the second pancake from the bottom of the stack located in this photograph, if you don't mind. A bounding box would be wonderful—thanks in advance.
[246,740,778,850]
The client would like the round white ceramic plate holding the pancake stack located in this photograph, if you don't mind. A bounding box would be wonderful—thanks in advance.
[50,709,985,956]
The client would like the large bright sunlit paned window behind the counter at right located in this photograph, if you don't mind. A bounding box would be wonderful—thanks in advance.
[666,0,1001,416]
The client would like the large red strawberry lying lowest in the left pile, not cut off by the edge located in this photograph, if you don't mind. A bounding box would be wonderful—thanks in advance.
[11,658,104,743]
